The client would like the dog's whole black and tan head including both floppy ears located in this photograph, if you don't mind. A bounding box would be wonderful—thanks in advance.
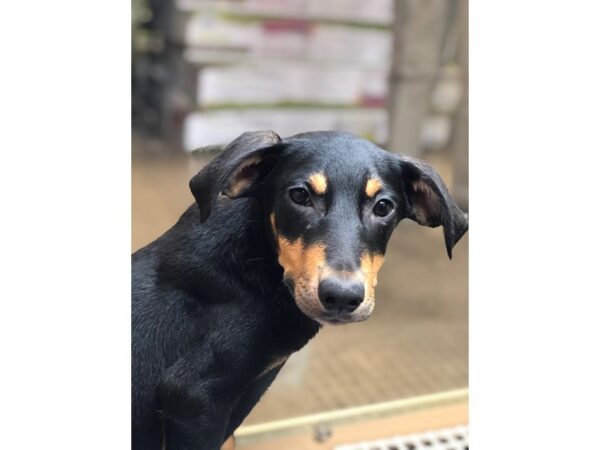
[190,131,468,324]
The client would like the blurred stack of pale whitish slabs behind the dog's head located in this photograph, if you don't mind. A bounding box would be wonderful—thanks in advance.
[162,0,393,151]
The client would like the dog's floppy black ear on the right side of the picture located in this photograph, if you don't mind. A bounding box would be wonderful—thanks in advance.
[399,156,469,258]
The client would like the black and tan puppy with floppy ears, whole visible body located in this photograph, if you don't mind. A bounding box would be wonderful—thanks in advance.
[132,131,467,450]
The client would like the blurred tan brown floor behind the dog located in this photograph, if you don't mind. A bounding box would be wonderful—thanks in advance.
[132,143,468,424]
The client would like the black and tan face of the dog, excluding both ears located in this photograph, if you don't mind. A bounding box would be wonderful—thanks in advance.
[269,135,403,323]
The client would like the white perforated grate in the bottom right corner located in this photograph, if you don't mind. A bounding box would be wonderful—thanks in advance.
[334,426,469,450]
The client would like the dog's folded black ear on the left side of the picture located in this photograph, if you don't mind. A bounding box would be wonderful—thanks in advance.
[190,131,281,222]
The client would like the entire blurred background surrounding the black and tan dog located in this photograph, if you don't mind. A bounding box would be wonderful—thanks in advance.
[132,0,468,450]
